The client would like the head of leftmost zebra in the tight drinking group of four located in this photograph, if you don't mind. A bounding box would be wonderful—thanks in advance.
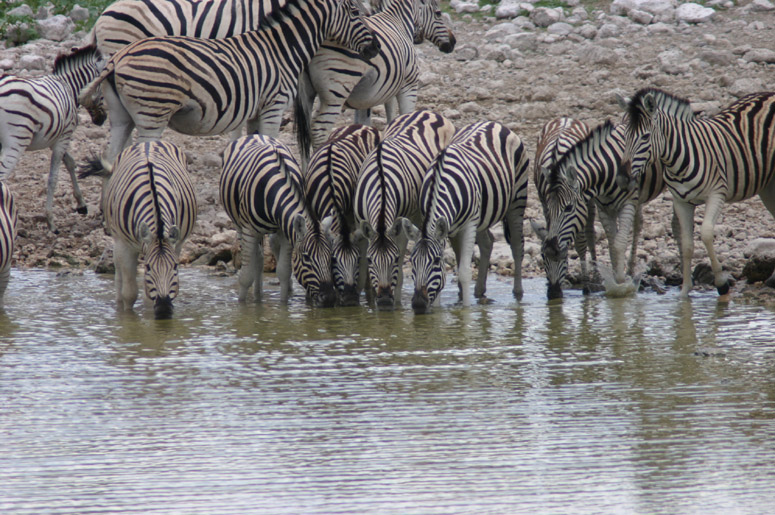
[291,214,336,308]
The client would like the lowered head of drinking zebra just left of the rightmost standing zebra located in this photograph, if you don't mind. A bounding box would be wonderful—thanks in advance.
[533,163,588,300]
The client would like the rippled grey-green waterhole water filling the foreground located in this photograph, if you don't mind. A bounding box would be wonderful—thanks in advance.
[0,270,775,515]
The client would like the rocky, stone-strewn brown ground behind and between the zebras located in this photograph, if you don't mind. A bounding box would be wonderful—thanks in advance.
[0,0,775,300]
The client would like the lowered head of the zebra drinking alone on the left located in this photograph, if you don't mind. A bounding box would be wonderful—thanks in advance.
[140,223,180,319]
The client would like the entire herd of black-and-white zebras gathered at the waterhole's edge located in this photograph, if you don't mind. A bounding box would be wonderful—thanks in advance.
[0,0,775,318]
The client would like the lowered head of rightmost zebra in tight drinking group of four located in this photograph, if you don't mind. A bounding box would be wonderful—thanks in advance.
[410,218,449,314]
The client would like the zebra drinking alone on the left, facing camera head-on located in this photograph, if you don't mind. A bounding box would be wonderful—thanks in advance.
[80,141,197,318]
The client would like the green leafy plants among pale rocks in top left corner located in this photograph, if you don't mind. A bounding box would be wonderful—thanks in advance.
[0,0,114,45]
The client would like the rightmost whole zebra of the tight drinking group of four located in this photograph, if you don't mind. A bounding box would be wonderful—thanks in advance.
[405,122,530,313]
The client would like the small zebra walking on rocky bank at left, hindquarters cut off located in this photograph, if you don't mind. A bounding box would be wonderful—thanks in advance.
[0,46,105,233]
